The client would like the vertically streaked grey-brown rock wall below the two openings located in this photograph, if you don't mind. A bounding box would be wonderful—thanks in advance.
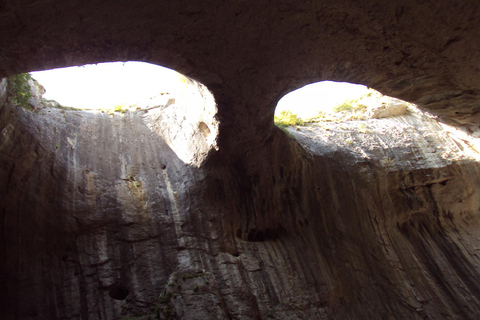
[0,78,480,319]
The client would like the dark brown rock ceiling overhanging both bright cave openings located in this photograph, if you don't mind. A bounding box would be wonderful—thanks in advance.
[0,0,480,131]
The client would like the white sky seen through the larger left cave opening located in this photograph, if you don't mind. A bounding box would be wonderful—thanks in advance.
[31,61,184,109]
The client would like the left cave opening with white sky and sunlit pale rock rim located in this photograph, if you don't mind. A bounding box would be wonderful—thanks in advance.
[0,61,218,166]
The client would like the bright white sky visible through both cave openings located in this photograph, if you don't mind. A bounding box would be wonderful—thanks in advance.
[31,62,368,114]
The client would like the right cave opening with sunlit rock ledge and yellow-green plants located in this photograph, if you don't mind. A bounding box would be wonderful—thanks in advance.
[274,81,480,170]
